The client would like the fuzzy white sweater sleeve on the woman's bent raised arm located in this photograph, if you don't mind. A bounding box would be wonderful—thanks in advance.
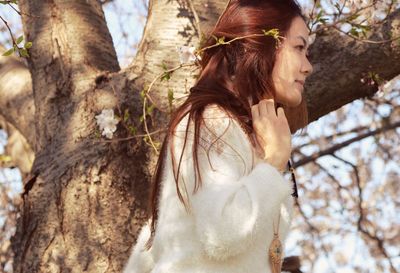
[170,104,291,260]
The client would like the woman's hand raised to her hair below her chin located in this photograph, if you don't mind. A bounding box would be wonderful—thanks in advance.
[251,99,292,171]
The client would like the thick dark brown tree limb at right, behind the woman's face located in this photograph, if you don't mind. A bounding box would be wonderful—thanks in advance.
[305,10,400,122]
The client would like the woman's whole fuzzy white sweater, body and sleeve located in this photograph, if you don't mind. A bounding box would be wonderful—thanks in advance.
[124,105,293,273]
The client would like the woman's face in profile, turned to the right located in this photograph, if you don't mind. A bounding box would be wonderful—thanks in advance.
[272,17,312,107]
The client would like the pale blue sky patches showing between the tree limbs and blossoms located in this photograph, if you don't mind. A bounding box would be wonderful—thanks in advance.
[0,0,400,273]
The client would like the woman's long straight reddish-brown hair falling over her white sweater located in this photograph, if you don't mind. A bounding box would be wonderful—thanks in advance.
[147,0,308,248]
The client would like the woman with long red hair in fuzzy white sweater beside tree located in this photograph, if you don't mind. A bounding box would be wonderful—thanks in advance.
[124,0,312,273]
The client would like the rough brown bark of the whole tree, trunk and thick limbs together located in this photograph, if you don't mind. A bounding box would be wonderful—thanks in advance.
[0,0,400,273]
